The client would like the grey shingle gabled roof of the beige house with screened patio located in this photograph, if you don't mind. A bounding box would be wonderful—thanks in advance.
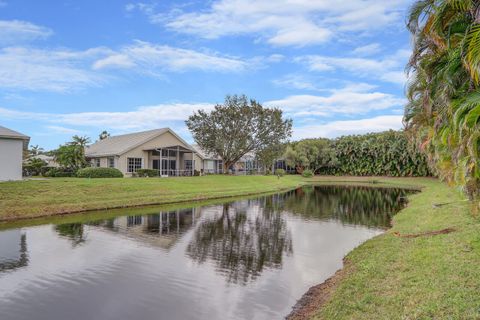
[85,128,193,157]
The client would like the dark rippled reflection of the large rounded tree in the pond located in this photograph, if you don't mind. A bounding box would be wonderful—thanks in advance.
[187,202,292,284]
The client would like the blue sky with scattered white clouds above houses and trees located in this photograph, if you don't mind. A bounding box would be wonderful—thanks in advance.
[0,0,411,149]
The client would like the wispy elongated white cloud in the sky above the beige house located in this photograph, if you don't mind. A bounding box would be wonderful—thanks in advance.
[93,41,253,73]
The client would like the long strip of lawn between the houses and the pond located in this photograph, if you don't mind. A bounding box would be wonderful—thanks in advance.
[0,176,304,221]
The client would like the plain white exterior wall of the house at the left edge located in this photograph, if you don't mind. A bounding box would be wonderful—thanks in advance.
[0,138,23,181]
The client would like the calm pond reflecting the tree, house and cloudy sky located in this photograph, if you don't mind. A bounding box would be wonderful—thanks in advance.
[0,186,407,320]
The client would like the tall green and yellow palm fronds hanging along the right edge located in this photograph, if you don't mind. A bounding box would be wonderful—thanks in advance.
[405,0,480,197]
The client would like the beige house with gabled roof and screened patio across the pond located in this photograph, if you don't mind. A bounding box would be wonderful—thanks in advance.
[85,128,204,176]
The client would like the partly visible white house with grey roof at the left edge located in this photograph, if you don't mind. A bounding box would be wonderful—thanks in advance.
[0,126,30,181]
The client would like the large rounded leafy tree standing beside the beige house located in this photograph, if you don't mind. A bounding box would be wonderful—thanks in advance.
[186,95,292,172]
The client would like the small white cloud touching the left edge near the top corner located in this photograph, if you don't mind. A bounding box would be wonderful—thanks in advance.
[0,20,53,45]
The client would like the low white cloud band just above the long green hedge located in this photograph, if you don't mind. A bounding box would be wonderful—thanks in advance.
[293,115,403,140]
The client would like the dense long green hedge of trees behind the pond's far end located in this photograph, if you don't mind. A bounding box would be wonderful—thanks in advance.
[284,130,432,177]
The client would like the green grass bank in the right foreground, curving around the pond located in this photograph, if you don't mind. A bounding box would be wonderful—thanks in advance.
[306,178,480,319]
